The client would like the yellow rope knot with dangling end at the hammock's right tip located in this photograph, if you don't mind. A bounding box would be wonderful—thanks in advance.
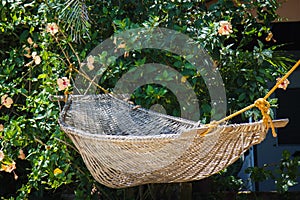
[254,98,277,137]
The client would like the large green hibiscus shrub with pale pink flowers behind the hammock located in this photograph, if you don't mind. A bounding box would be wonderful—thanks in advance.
[0,0,296,199]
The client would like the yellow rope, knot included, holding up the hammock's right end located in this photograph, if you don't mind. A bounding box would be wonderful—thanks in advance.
[201,60,300,137]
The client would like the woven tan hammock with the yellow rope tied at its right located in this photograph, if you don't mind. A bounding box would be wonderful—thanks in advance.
[59,60,300,188]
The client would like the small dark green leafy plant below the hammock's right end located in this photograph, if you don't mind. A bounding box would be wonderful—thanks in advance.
[246,150,300,193]
